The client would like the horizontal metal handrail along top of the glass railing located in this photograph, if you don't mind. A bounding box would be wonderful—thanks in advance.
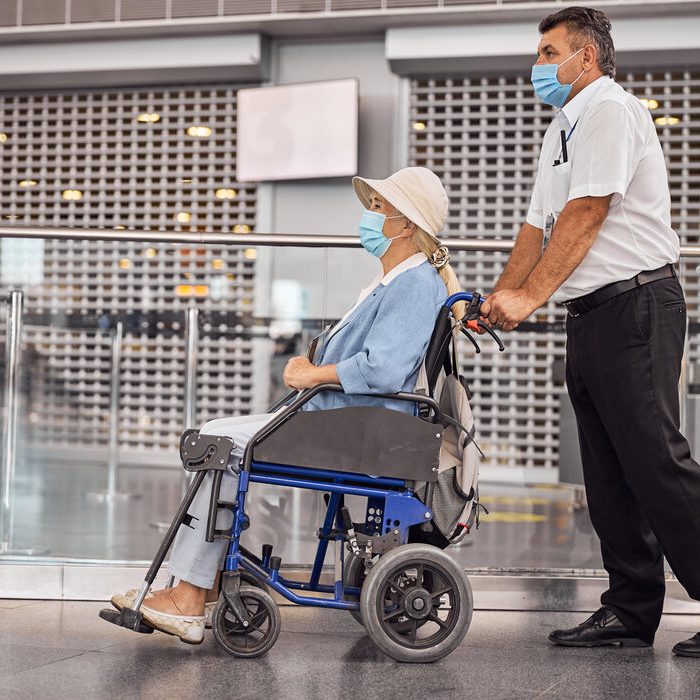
[0,226,700,258]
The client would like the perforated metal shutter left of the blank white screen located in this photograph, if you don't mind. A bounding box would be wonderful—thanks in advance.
[0,86,257,453]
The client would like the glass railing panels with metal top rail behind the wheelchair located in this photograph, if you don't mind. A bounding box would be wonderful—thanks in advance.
[0,229,700,584]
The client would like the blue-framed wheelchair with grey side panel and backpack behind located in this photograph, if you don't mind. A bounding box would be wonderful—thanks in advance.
[100,292,504,662]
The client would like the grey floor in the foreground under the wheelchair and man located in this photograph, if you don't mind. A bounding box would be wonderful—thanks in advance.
[0,600,700,700]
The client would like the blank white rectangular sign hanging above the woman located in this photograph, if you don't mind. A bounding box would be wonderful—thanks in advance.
[236,79,358,182]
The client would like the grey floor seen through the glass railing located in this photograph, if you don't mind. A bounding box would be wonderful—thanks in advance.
[2,462,601,569]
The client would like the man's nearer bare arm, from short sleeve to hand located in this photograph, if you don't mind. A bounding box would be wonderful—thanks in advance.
[481,195,612,331]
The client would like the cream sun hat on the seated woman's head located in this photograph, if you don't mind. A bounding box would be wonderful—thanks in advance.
[352,167,448,245]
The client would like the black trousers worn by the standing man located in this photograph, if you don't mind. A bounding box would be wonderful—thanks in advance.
[566,278,700,642]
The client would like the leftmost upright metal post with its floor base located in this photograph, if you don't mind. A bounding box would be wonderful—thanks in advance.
[0,290,49,556]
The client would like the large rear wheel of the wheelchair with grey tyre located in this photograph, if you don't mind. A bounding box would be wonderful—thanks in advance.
[360,544,474,663]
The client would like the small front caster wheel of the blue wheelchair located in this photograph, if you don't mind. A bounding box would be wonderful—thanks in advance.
[212,586,282,659]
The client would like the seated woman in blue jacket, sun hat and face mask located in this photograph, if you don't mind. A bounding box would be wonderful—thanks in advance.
[112,168,459,644]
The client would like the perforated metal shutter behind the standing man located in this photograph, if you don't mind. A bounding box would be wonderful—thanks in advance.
[409,70,700,468]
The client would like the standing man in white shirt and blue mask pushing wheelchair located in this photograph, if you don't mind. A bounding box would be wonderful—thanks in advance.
[482,7,700,658]
